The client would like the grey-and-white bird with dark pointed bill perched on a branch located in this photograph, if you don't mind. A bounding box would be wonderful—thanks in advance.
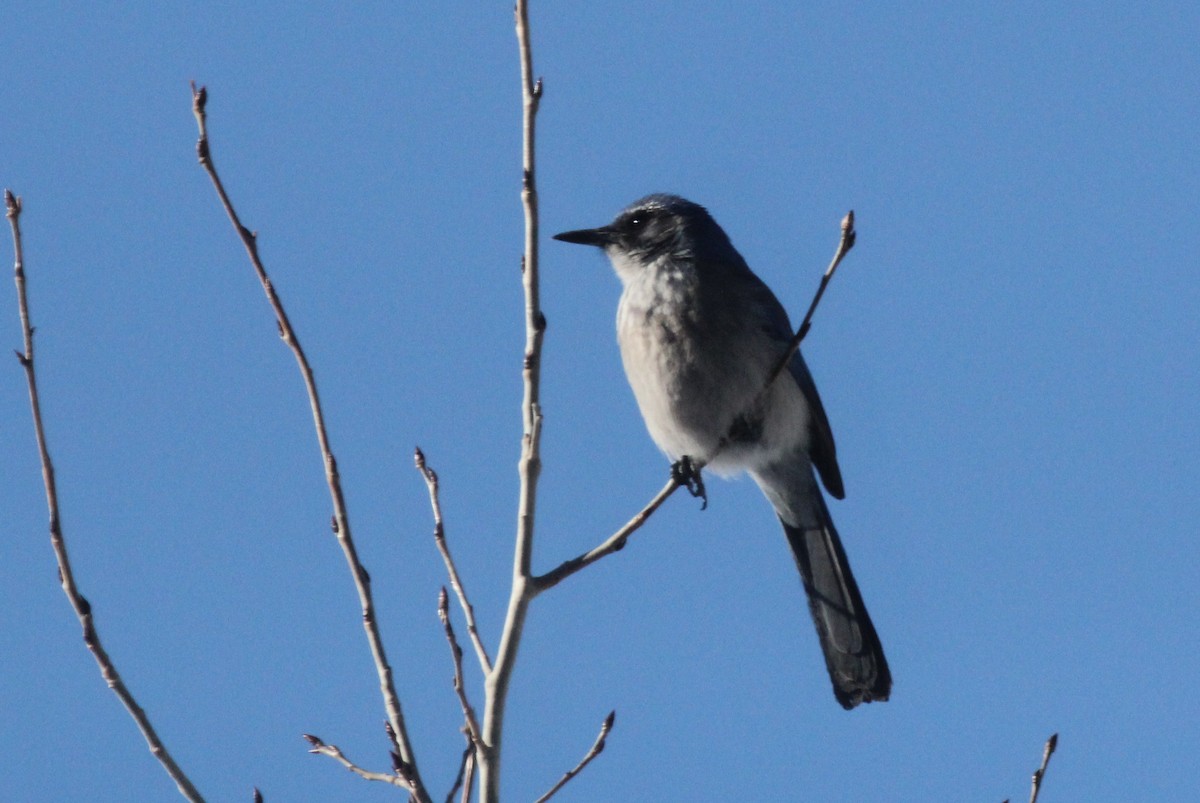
[554,193,892,711]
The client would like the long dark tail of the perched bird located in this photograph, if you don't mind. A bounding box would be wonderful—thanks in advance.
[754,461,892,709]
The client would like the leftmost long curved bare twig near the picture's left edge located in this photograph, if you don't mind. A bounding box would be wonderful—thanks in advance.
[4,190,204,801]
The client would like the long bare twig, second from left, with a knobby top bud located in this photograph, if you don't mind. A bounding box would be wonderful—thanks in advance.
[192,83,430,803]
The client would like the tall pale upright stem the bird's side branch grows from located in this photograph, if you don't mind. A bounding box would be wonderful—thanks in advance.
[479,0,546,803]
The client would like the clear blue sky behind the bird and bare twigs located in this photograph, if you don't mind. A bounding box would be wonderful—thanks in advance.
[0,1,1200,801]
